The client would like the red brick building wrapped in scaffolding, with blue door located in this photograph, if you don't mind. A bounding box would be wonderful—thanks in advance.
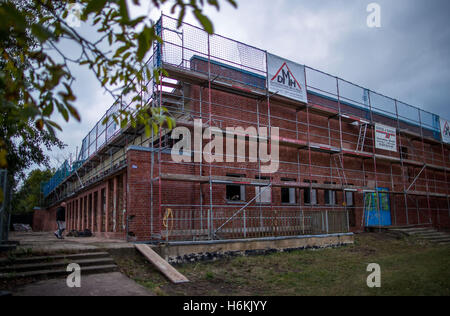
[34,16,450,242]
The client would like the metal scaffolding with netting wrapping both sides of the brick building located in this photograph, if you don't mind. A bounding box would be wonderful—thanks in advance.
[43,15,450,241]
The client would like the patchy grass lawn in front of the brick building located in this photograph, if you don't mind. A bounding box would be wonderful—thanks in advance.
[115,233,450,296]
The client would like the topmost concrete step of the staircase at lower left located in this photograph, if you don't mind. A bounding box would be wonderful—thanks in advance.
[0,252,110,267]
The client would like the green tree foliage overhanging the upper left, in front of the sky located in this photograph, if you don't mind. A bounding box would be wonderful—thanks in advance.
[0,0,236,202]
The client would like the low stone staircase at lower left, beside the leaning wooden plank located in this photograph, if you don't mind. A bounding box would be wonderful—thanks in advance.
[0,252,118,281]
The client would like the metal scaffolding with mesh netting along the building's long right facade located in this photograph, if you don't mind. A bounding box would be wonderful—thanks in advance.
[150,16,450,239]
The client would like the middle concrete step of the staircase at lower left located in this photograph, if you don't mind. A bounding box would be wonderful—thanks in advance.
[0,258,114,273]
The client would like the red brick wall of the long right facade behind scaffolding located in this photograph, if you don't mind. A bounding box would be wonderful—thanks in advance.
[145,81,448,239]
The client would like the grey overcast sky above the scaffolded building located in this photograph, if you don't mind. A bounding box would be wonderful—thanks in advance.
[43,0,450,167]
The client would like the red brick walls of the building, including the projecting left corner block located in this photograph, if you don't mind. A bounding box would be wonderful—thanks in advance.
[36,63,450,241]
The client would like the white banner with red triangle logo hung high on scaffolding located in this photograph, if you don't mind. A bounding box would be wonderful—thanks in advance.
[267,53,308,103]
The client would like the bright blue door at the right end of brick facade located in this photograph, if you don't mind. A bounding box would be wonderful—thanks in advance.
[364,188,392,227]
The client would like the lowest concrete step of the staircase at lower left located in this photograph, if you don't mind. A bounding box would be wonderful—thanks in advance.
[0,264,118,280]
